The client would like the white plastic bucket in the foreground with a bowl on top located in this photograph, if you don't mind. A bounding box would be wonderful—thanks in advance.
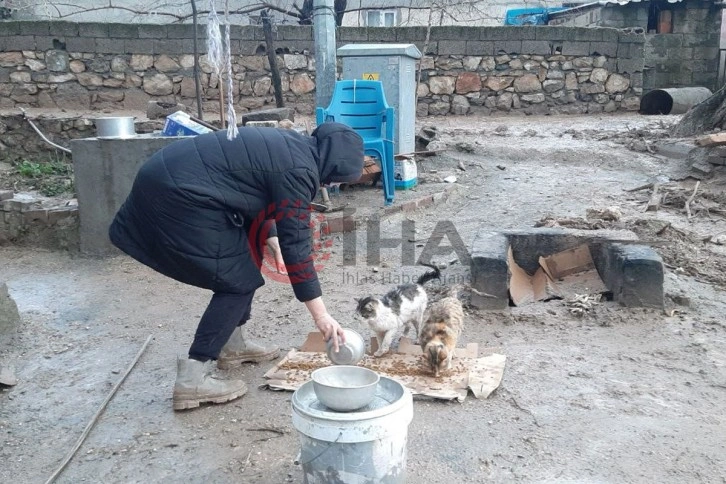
[292,377,413,484]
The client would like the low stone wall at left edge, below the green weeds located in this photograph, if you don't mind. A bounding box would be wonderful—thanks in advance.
[0,190,79,251]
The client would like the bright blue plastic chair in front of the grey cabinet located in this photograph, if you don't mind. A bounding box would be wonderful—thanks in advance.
[315,79,396,205]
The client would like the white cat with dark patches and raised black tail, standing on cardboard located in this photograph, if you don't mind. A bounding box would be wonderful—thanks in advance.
[356,264,441,357]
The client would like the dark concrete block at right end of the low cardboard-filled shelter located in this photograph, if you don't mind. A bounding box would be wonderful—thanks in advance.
[598,244,664,308]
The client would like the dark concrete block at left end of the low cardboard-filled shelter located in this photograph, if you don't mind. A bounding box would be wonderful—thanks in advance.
[471,230,509,311]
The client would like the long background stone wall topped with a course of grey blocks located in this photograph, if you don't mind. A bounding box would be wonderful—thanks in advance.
[0,21,643,121]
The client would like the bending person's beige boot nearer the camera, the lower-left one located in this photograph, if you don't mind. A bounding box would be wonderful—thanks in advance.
[172,358,247,410]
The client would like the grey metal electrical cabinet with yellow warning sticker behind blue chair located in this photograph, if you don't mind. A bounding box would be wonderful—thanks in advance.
[338,44,421,154]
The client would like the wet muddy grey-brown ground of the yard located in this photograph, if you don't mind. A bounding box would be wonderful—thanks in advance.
[0,115,726,483]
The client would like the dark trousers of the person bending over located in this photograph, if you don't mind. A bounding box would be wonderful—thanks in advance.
[189,291,255,361]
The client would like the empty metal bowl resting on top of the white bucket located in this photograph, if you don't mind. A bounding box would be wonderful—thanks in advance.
[312,365,380,412]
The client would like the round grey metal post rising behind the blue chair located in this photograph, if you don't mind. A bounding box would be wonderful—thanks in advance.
[313,0,337,107]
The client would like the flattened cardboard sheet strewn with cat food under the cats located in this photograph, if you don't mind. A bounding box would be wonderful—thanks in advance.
[265,333,506,402]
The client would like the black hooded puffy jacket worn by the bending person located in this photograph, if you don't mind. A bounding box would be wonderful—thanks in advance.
[109,123,363,301]
